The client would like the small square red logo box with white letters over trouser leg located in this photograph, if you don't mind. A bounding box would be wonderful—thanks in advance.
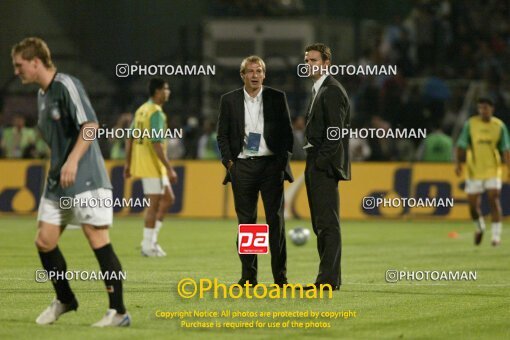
[237,224,269,254]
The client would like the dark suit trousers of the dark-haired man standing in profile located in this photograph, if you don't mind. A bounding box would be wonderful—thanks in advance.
[305,150,342,286]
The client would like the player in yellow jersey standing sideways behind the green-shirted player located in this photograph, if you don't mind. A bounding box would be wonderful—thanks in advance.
[124,78,177,257]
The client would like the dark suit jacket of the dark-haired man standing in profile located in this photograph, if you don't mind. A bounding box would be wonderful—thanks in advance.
[305,76,351,181]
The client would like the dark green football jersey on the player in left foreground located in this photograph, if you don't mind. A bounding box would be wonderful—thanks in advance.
[37,73,112,201]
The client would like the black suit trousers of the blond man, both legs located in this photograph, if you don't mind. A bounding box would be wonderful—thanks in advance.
[229,156,287,283]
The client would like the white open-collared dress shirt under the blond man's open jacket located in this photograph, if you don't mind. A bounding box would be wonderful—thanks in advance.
[237,87,274,158]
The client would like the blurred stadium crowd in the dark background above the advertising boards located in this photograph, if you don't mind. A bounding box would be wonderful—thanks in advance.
[0,0,510,161]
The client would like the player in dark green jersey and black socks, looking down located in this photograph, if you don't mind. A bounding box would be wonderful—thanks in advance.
[11,38,131,327]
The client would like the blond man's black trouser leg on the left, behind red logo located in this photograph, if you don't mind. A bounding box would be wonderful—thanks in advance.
[230,160,259,282]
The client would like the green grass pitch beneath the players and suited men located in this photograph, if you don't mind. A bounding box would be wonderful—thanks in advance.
[0,217,510,340]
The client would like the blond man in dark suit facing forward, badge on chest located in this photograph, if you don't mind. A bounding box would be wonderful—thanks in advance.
[218,56,294,286]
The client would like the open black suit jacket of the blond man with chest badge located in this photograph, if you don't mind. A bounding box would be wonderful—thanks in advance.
[217,86,294,184]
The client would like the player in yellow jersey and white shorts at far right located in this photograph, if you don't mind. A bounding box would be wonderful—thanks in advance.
[455,98,510,246]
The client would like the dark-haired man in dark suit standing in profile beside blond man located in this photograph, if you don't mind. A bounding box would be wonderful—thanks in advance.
[304,43,351,290]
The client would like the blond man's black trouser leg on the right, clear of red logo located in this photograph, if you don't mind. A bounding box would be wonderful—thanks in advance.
[260,160,287,283]
